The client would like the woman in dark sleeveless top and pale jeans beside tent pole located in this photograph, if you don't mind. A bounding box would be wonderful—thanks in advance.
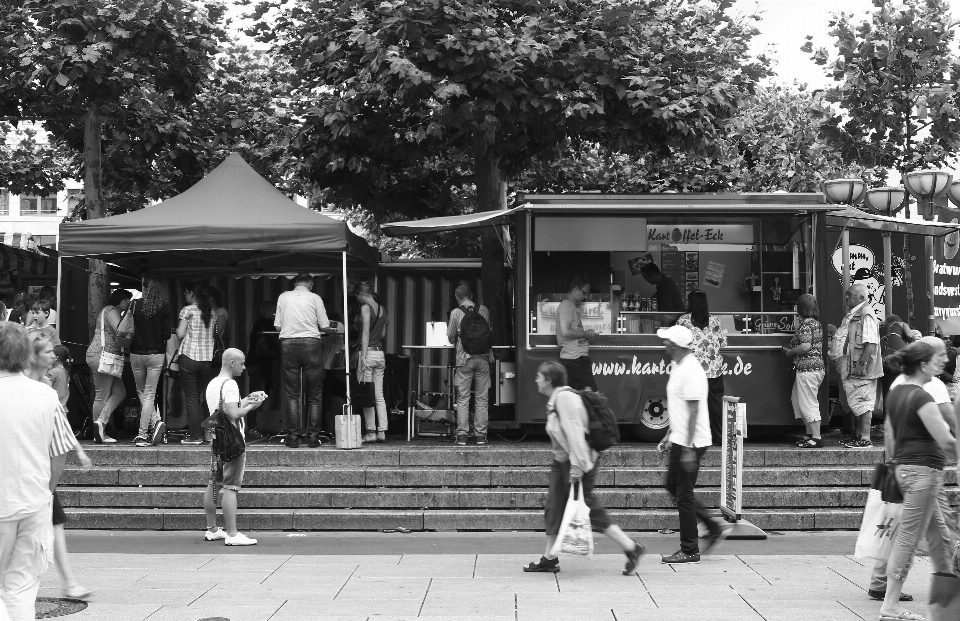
[353,282,390,443]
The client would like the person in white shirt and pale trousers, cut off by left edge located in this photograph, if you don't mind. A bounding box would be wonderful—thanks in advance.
[0,322,76,621]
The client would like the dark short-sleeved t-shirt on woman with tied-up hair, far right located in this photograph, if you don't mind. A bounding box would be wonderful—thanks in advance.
[887,384,947,470]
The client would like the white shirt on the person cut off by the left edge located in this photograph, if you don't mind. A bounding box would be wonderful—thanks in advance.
[0,375,76,520]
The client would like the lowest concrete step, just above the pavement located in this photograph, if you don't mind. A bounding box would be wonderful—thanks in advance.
[66,508,863,532]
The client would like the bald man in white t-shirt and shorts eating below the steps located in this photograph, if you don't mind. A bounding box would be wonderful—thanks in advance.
[203,347,267,546]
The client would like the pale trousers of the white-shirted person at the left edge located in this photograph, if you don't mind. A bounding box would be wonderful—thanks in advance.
[0,509,51,621]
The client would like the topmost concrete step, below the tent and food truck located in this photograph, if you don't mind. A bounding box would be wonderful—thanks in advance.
[68,443,883,468]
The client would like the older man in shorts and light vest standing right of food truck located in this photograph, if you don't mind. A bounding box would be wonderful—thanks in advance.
[830,283,883,449]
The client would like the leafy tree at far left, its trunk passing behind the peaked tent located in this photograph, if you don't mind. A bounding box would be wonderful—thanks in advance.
[0,0,223,331]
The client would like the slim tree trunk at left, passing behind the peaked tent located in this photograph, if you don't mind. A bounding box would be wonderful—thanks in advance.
[83,105,110,339]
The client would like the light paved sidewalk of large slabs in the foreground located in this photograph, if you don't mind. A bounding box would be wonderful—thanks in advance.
[40,533,931,621]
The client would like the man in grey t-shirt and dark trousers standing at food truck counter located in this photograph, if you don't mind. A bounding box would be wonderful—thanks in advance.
[557,274,599,392]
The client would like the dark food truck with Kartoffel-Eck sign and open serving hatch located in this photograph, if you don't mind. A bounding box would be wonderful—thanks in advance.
[383,193,956,441]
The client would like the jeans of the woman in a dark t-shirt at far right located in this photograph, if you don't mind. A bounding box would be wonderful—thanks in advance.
[887,465,953,580]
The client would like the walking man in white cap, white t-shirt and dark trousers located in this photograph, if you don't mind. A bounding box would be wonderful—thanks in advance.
[657,326,729,564]
